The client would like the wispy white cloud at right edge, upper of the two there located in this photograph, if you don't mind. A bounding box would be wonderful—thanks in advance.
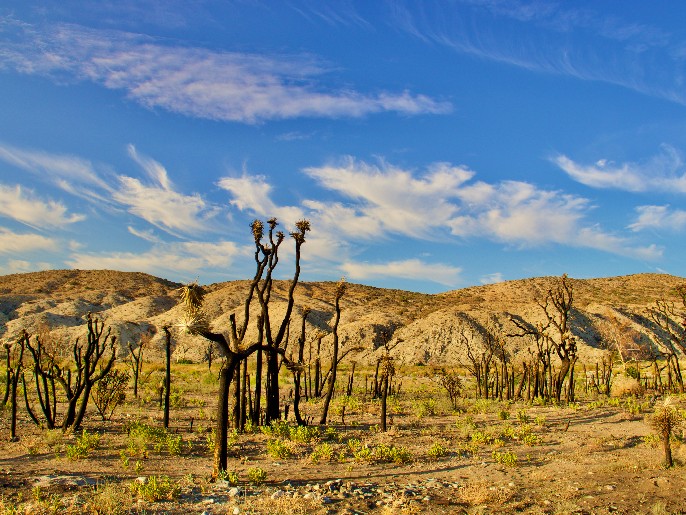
[552,145,686,193]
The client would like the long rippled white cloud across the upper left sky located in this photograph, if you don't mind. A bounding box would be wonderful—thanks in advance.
[0,24,451,123]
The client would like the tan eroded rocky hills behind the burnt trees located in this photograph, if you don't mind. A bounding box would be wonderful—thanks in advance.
[0,270,686,365]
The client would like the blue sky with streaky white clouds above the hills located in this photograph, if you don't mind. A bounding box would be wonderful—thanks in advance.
[0,0,686,292]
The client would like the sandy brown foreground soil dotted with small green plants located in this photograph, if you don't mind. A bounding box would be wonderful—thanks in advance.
[0,388,686,514]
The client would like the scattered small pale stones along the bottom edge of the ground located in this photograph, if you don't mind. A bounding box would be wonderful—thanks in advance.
[201,478,460,515]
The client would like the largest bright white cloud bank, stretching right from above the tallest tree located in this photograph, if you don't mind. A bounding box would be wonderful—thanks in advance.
[220,159,661,262]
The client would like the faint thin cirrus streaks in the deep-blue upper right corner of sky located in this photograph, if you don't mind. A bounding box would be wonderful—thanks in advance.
[390,0,686,105]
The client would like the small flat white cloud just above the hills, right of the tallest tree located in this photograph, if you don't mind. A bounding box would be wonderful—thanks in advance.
[340,259,462,287]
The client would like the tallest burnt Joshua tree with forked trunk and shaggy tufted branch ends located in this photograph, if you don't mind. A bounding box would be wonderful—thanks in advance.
[182,218,310,477]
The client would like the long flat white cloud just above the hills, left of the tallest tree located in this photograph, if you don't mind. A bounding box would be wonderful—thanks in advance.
[66,241,244,276]
